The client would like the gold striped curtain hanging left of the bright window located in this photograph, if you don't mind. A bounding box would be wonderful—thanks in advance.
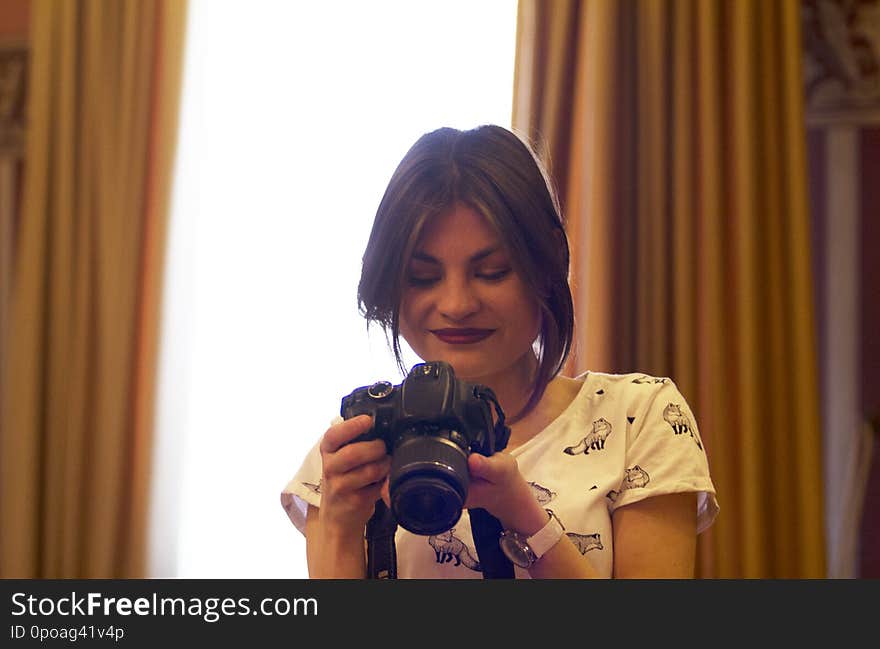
[0,0,186,578]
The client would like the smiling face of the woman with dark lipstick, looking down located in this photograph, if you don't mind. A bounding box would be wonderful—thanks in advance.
[400,204,540,386]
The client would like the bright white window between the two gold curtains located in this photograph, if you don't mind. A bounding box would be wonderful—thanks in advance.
[150,0,516,578]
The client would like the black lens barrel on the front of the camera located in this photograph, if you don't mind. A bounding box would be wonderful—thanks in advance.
[389,435,469,535]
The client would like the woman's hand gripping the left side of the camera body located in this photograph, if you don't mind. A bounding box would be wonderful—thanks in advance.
[319,415,391,539]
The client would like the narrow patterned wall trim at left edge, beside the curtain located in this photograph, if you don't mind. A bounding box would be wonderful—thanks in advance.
[0,39,28,158]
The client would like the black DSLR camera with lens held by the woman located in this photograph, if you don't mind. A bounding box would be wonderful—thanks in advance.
[340,361,510,535]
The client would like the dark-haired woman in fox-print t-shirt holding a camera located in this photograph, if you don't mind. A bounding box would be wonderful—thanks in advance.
[282,126,718,578]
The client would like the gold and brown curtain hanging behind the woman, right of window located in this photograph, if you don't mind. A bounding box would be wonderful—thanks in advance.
[513,0,825,578]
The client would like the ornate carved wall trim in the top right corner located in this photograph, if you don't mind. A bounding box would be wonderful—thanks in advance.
[801,0,880,125]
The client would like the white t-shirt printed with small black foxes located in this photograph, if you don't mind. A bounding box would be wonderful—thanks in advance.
[281,372,718,579]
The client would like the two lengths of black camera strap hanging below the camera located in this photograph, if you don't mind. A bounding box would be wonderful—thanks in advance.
[366,499,515,579]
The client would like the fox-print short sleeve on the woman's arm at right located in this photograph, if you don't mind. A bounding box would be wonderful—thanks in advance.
[611,378,719,534]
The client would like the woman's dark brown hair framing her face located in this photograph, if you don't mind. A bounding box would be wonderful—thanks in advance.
[358,125,574,420]
